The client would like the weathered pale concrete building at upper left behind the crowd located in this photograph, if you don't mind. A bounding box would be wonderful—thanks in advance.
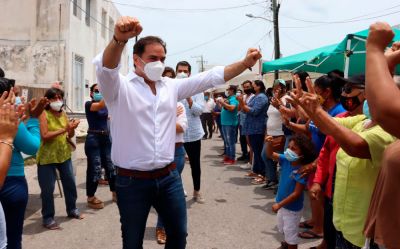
[0,0,128,112]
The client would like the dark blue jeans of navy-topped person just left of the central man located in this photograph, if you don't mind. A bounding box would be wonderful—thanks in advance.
[85,133,115,197]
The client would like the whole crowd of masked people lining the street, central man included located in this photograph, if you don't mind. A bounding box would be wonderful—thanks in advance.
[0,17,400,249]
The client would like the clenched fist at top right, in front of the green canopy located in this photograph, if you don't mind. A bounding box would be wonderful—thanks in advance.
[367,22,394,51]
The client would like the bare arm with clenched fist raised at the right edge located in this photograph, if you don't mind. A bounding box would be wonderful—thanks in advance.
[366,23,400,137]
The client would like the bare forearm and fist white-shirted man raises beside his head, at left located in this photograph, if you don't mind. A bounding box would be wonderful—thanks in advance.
[103,16,143,69]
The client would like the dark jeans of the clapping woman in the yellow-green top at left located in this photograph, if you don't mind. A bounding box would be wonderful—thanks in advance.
[38,159,78,225]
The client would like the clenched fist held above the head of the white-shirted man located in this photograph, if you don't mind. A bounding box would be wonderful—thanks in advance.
[114,16,143,42]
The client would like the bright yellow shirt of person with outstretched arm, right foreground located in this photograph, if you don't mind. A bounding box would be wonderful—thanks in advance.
[333,115,395,247]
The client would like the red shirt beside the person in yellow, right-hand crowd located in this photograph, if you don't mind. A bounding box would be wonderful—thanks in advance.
[313,112,350,199]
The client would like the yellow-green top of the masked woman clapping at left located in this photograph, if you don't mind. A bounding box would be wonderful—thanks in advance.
[36,111,71,165]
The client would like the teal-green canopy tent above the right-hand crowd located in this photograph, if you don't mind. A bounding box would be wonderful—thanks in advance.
[262,29,400,76]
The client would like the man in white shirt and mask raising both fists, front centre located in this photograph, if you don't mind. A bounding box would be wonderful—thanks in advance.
[94,17,261,249]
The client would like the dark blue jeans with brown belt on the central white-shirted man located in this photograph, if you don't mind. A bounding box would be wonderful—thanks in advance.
[115,169,187,249]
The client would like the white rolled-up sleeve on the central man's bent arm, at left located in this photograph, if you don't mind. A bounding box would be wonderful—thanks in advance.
[93,53,121,103]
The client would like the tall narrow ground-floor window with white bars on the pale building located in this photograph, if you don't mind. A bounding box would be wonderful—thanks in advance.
[72,55,85,111]
